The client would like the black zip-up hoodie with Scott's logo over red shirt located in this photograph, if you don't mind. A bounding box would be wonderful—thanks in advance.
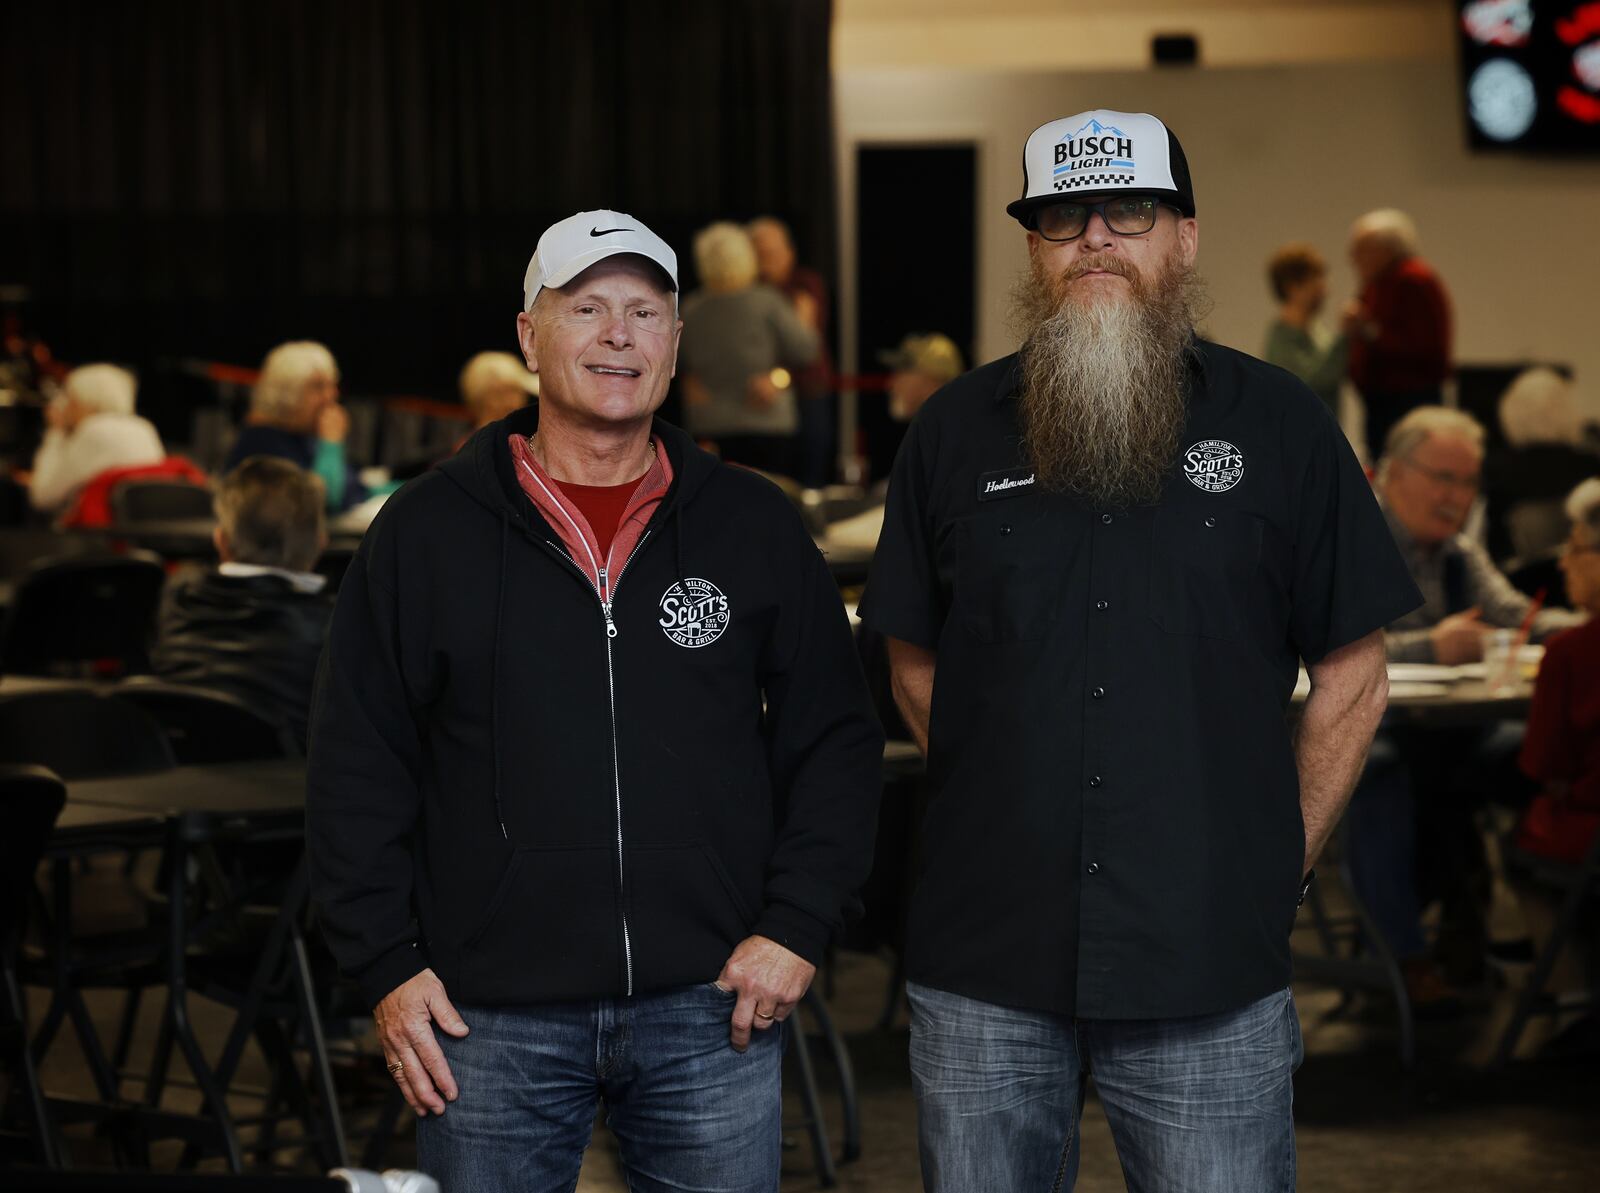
[306,409,883,1006]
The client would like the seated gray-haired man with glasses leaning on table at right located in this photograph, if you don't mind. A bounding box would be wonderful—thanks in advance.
[1349,406,1582,1012]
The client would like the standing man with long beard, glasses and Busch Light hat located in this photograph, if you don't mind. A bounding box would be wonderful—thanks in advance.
[862,110,1419,1193]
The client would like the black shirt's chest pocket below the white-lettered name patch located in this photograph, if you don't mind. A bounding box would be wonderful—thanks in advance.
[955,502,1061,643]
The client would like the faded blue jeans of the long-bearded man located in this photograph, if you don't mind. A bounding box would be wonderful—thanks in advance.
[907,984,1301,1193]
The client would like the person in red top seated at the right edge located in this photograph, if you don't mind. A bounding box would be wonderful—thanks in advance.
[1517,477,1600,862]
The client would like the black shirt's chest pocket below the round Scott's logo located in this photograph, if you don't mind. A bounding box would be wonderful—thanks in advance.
[1150,505,1262,641]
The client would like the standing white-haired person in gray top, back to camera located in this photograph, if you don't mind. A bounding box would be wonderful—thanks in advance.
[678,224,819,477]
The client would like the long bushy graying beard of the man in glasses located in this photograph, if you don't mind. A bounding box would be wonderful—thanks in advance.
[1013,257,1203,509]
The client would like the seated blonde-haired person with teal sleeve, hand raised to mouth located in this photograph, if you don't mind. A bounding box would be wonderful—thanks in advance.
[224,341,368,512]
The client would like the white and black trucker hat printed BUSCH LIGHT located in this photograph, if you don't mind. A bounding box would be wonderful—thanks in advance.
[1006,107,1195,227]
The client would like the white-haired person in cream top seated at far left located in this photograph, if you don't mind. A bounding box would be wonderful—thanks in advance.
[27,365,166,513]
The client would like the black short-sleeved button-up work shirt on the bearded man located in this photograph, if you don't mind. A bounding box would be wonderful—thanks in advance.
[861,341,1421,1019]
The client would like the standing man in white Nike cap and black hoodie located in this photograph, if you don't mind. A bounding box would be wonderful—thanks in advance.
[307,211,883,1193]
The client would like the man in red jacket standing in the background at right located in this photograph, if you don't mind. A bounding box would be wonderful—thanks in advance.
[1344,208,1450,461]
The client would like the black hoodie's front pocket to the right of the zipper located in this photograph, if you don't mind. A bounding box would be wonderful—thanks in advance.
[627,843,755,990]
